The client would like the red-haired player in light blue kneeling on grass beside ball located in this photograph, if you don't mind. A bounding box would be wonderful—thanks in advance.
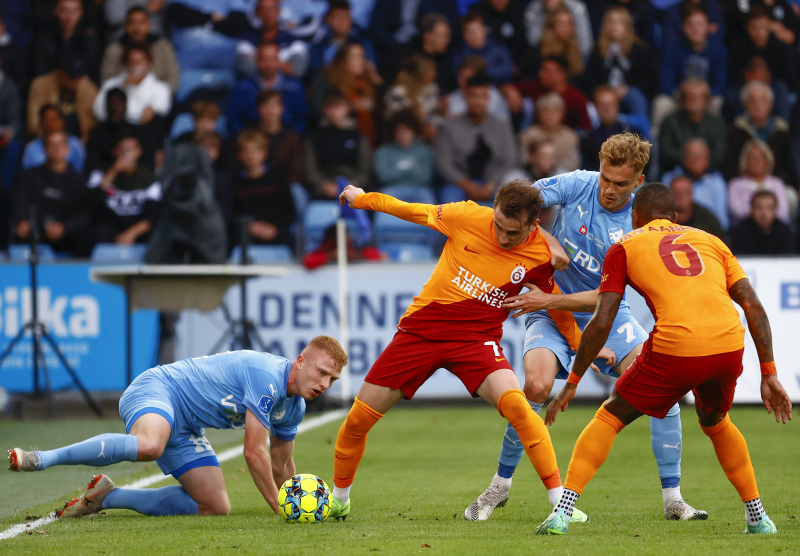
[8,336,347,518]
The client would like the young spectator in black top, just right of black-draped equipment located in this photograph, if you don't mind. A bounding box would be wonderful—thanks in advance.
[233,129,296,247]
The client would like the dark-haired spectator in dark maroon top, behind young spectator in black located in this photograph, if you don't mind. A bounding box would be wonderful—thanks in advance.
[256,91,305,184]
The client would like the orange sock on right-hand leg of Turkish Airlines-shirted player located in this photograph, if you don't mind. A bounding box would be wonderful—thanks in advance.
[497,390,561,490]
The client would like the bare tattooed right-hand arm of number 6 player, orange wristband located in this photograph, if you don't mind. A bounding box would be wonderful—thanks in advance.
[728,278,792,423]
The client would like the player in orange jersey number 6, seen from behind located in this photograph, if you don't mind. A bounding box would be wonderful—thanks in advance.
[537,183,792,534]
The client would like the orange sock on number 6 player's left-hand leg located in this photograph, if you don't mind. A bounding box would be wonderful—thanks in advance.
[564,405,625,494]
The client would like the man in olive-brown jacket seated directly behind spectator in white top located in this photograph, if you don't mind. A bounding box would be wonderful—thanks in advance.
[100,6,180,93]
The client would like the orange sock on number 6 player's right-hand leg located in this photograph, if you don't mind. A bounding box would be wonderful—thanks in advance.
[700,415,759,502]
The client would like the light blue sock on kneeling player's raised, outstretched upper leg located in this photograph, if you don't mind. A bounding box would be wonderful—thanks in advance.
[36,433,139,471]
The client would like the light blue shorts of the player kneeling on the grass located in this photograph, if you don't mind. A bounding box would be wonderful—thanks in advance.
[119,369,219,479]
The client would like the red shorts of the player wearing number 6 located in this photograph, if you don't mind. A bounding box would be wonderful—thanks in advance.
[616,340,744,419]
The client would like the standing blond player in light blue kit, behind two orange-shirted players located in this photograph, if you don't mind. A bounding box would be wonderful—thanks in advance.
[464,133,708,521]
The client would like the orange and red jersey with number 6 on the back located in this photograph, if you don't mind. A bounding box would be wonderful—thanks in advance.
[600,220,747,357]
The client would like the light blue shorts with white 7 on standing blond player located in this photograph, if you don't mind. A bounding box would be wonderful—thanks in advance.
[523,301,648,379]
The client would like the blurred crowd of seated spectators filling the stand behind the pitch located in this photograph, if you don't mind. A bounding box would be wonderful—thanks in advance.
[0,0,800,262]
